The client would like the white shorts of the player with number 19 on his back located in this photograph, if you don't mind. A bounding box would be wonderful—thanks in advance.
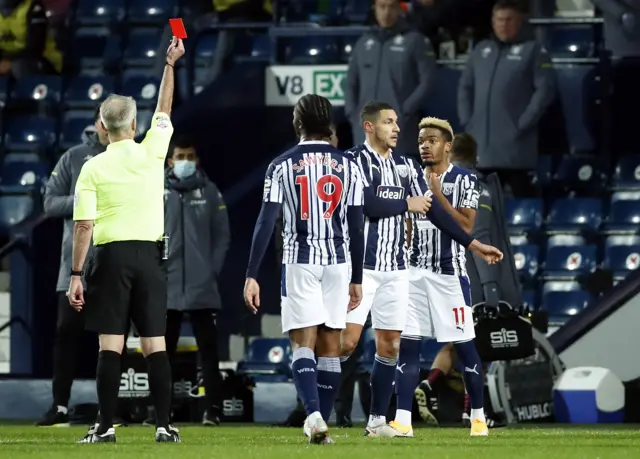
[280,263,351,333]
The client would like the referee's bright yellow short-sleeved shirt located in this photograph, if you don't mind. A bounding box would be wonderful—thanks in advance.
[73,113,173,245]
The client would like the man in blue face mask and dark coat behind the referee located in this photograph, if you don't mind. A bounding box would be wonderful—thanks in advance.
[157,139,230,426]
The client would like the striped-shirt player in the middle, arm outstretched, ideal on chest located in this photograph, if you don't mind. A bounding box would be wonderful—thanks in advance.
[342,102,502,437]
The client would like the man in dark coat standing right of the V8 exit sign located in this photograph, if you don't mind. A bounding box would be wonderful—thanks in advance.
[344,0,437,160]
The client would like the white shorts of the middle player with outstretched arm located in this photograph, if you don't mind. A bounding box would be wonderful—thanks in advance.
[347,269,409,331]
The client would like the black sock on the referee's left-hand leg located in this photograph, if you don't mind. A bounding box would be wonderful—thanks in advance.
[96,351,121,434]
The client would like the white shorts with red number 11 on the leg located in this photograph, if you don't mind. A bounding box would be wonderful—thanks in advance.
[403,267,476,343]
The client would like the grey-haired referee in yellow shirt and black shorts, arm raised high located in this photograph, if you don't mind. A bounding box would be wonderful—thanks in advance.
[68,37,184,443]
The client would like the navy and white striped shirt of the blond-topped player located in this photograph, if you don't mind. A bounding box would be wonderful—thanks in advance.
[409,164,480,276]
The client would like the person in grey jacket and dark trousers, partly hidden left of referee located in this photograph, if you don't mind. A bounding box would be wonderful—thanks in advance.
[36,106,109,427]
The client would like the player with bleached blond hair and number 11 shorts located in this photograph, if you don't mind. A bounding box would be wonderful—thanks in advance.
[392,118,488,436]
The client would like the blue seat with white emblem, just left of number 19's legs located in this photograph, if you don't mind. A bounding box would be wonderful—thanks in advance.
[237,337,292,382]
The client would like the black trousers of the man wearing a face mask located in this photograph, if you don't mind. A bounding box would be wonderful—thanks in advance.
[165,309,222,412]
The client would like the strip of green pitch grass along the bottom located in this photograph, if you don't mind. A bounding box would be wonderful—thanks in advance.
[0,425,640,459]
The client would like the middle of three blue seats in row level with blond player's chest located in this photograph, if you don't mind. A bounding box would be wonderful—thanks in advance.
[546,198,602,234]
